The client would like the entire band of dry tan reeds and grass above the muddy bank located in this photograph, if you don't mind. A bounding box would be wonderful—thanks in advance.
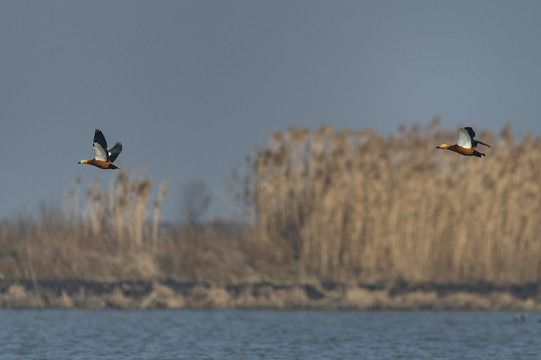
[0,121,541,296]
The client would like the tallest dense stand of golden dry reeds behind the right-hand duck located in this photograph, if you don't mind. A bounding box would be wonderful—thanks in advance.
[248,119,541,283]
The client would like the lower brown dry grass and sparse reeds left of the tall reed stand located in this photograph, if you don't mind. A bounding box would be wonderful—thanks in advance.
[0,171,273,283]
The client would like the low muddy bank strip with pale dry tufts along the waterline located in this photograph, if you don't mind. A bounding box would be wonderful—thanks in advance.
[0,280,541,310]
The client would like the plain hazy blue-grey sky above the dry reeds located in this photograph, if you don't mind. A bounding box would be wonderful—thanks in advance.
[0,0,541,220]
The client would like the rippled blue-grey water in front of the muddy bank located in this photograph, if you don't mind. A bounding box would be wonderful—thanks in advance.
[0,310,541,360]
